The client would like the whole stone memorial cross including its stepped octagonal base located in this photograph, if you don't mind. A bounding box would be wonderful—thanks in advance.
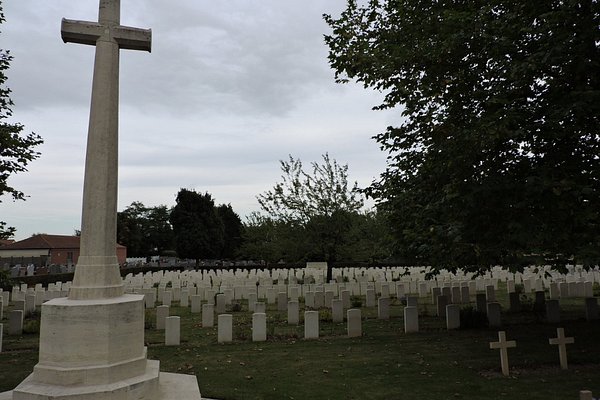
[0,0,200,400]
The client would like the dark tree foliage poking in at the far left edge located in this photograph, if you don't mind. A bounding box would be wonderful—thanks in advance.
[0,1,43,239]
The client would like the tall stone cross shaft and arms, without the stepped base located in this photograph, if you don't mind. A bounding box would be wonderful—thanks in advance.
[61,0,152,300]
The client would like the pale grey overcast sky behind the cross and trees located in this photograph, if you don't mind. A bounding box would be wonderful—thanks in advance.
[0,0,399,240]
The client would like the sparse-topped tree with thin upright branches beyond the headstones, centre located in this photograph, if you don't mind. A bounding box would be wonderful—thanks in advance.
[243,154,388,279]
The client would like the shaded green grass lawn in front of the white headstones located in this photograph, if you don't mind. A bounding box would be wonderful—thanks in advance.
[0,291,600,400]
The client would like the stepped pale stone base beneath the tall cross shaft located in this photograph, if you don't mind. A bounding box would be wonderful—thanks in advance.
[0,295,201,400]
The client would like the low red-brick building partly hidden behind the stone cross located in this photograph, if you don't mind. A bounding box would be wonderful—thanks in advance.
[0,234,127,267]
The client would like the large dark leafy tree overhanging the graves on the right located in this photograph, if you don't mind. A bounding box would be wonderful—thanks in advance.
[324,0,600,271]
